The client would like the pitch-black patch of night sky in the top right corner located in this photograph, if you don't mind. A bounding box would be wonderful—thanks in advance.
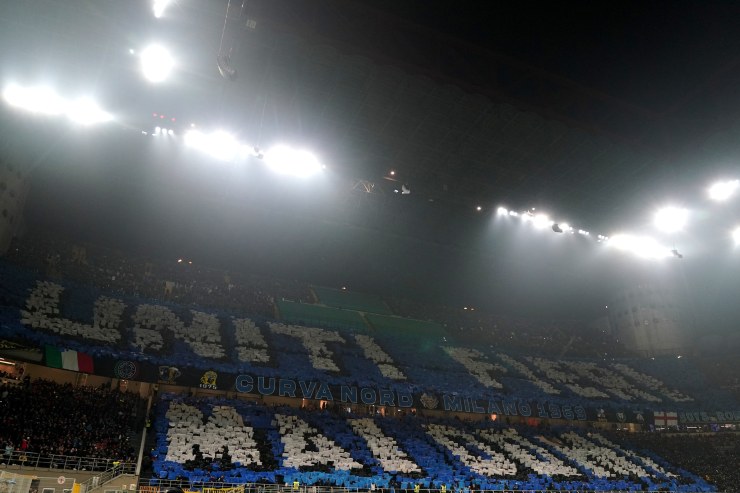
[366,0,740,113]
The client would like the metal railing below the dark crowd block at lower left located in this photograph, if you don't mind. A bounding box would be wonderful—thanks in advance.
[0,450,136,475]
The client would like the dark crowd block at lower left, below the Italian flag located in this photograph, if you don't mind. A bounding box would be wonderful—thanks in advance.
[0,379,145,461]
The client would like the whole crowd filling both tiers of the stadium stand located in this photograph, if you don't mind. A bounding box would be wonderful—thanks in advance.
[0,233,737,491]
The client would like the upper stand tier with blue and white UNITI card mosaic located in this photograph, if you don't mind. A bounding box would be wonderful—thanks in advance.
[0,263,737,412]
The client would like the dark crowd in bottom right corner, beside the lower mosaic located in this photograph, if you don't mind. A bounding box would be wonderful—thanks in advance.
[608,432,740,492]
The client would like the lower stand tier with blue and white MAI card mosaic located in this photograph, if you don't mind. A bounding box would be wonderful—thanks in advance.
[153,395,724,491]
